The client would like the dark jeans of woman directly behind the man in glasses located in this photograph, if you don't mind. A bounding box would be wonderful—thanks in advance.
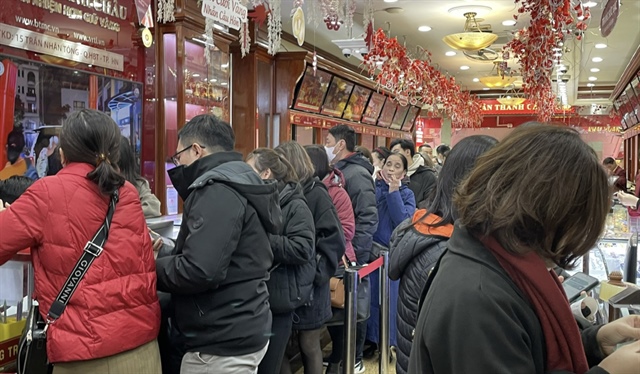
[258,313,293,374]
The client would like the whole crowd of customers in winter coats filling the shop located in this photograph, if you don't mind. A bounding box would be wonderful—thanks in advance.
[0,109,640,374]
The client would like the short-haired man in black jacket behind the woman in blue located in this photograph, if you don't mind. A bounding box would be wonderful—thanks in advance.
[391,139,436,208]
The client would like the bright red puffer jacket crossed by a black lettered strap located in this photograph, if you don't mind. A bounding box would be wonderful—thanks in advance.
[0,164,160,363]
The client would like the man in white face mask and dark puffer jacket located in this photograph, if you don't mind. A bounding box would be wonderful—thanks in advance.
[325,125,378,373]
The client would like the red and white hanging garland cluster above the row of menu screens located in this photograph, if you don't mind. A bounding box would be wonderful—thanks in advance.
[364,29,482,127]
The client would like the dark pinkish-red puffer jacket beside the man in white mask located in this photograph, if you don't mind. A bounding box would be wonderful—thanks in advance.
[322,169,356,261]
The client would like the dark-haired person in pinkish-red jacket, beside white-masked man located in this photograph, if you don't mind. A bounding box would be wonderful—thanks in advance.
[304,145,356,262]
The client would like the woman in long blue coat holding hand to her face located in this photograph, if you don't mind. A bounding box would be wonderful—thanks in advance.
[367,153,416,359]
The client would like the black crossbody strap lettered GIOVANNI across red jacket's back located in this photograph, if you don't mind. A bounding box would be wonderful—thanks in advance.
[47,191,119,327]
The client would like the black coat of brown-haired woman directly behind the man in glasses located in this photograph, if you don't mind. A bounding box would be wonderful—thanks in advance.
[267,183,316,313]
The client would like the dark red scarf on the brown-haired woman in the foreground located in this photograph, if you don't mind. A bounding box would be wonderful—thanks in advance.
[482,237,589,373]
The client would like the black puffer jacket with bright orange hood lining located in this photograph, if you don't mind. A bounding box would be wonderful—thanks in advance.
[389,210,451,374]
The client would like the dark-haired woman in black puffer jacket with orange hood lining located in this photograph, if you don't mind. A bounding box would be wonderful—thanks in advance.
[389,135,497,374]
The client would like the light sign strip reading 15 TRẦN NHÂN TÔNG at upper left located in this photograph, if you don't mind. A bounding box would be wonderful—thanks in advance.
[0,23,124,71]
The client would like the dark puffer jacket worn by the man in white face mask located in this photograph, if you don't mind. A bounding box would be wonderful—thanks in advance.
[335,153,378,264]
